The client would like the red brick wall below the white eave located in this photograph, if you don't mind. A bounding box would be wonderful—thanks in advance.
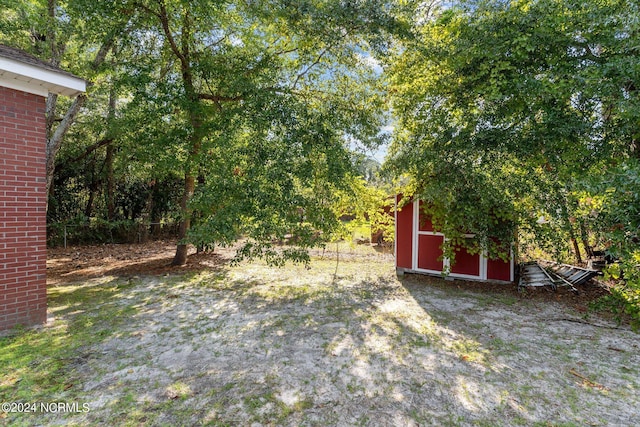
[0,87,47,330]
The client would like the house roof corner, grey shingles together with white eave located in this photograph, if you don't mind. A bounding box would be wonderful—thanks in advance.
[0,44,87,96]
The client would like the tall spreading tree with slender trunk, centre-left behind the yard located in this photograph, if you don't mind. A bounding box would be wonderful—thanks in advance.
[121,0,404,265]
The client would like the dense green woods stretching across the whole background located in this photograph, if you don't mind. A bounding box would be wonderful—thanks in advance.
[0,0,640,318]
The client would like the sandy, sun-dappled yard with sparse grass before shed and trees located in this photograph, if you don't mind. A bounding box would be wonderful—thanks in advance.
[0,242,640,426]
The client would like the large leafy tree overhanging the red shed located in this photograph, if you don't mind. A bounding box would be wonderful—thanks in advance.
[386,0,640,262]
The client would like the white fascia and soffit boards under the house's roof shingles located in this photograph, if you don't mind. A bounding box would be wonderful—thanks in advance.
[0,57,87,96]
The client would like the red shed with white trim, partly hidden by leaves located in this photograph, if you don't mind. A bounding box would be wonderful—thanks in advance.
[395,196,514,282]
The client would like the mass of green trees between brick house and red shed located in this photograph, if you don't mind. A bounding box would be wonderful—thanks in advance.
[0,0,413,263]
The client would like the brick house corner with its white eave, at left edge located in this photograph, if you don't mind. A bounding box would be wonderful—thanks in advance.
[0,45,85,330]
